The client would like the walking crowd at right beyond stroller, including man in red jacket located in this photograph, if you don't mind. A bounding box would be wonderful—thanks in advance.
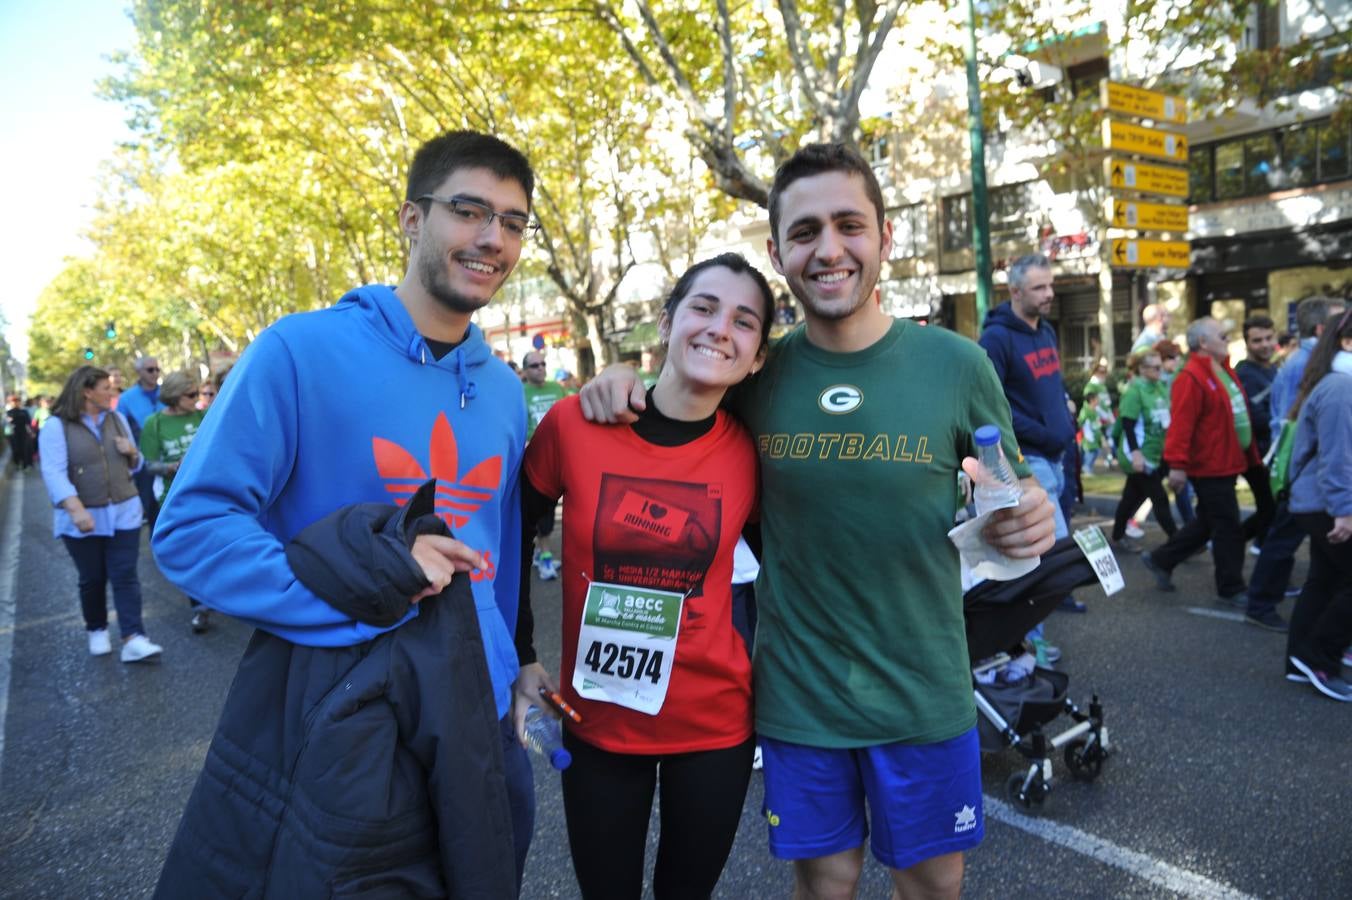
[1065,292,1352,701]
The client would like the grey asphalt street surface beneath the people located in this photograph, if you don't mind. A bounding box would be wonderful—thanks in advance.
[0,474,1352,900]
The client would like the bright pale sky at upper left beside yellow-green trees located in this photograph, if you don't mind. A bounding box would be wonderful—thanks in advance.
[0,0,135,358]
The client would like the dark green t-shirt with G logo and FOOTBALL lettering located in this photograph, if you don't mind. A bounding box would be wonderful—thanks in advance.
[734,320,1028,747]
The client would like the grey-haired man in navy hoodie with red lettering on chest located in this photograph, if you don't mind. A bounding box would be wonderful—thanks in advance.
[979,253,1084,624]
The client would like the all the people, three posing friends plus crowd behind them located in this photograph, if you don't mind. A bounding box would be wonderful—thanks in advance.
[7,120,1352,899]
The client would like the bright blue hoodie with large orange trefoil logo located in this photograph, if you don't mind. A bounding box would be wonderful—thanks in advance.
[151,285,526,716]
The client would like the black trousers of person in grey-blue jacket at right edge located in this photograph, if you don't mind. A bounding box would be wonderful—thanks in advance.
[1286,512,1352,674]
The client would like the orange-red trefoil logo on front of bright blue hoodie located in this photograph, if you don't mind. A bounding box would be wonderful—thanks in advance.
[370,412,503,528]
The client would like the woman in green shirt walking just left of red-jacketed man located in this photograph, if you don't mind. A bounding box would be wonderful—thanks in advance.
[1110,350,1178,553]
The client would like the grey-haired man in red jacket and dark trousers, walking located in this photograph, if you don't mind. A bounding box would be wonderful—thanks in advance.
[1141,318,1260,604]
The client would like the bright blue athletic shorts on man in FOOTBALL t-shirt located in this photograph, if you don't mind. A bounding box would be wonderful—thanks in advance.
[760,727,986,869]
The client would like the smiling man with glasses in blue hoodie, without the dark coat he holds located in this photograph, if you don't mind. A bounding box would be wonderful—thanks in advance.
[153,131,535,896]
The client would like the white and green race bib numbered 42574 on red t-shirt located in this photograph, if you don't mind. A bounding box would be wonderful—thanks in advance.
[573,581,684,716]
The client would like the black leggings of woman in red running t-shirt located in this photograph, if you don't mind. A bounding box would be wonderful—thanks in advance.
[562,731,756,900]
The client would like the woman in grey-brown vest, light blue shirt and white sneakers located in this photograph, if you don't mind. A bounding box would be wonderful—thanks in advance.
[38,366,162,662]
